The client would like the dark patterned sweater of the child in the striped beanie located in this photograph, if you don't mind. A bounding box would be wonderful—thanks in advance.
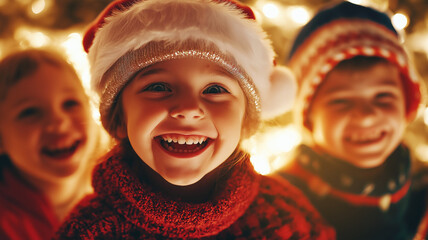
[279,145,423,240]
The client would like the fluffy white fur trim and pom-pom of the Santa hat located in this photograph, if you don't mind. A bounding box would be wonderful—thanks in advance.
[88,0,295,123]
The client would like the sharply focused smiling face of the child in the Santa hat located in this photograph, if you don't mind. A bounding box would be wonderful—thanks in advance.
[118,58,246,185]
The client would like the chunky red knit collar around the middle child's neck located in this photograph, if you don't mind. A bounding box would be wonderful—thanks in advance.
[93,147,260,238]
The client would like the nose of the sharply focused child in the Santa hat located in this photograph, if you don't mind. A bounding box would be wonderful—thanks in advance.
[170,94,205,120]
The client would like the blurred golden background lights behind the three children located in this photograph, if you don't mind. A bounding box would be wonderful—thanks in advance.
[0,0,428,173]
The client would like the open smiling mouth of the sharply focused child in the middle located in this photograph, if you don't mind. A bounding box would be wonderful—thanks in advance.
[156,134,210,155]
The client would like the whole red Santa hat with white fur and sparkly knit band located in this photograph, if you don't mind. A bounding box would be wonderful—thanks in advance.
[83,0,296,139]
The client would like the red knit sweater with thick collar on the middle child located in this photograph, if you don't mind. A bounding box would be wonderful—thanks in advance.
[56,145,335,240]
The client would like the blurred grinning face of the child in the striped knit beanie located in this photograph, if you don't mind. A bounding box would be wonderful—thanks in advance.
[309,63,407,168]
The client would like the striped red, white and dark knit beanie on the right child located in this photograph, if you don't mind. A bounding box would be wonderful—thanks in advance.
[288,1,421,128]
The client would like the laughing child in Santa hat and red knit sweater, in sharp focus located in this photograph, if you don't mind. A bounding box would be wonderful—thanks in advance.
[57,0,334,239]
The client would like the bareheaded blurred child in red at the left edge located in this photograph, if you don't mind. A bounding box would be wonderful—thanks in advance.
[0,49,106,240]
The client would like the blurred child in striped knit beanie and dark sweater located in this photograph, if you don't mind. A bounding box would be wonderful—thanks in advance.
[279,1,423,240]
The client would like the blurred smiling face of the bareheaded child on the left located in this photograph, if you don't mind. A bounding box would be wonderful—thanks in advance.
[0,63,94,182]
